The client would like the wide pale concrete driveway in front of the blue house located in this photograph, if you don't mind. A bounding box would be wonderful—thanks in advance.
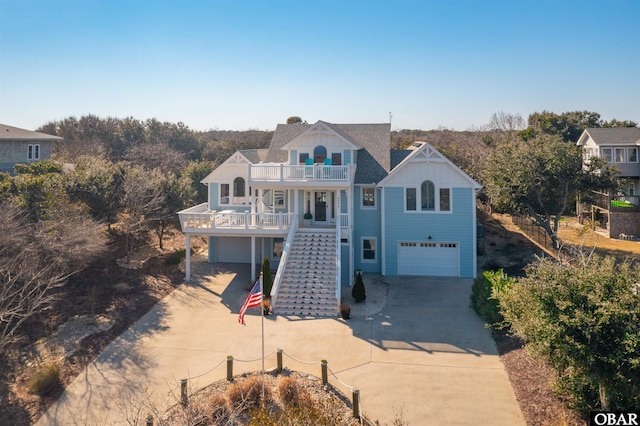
[37,263,525,425]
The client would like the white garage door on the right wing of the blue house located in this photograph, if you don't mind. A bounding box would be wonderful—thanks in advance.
[398,241,460,277]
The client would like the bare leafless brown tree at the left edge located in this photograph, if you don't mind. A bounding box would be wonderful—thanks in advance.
[0,203,106,351]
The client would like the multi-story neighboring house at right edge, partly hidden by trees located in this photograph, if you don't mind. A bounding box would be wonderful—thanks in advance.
[577,127,640,238]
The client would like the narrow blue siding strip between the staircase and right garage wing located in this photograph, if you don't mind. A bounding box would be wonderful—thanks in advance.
[351,186,382,273]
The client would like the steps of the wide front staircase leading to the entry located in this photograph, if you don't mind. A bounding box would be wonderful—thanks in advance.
[275,229,338,317]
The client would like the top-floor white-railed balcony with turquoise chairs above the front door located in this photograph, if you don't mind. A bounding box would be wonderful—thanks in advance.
[249,163,356,186]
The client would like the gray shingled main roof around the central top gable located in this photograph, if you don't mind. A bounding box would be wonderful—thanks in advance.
[267,121,391,184]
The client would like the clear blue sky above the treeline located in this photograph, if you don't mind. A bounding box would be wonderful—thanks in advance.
[0,0,640,130]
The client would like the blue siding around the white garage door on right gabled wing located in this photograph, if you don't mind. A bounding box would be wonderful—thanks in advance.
[384,187,476,278]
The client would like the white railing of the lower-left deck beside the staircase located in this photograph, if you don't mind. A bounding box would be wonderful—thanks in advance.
[178,203,297,233]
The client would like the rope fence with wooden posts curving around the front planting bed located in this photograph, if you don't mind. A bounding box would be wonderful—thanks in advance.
[146,348,361,426]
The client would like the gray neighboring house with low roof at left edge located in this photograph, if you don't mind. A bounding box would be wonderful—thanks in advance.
[0,124,62,174]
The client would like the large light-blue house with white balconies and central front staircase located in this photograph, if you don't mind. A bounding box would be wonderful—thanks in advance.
[179,121,480,315]
